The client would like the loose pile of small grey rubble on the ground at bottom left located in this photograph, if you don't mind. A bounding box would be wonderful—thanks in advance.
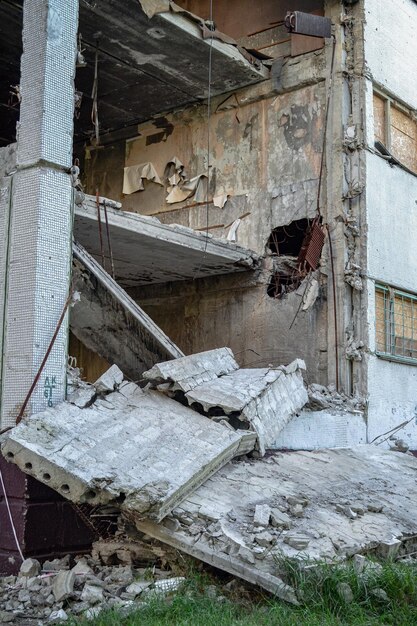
[0,556,185,624]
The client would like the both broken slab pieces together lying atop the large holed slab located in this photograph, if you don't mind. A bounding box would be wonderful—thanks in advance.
[144,348,308,454]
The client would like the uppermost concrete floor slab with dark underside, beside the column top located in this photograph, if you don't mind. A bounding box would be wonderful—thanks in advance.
[75,0,269,139]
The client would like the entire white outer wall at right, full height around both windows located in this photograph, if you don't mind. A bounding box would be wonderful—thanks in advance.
[364,0,417,450]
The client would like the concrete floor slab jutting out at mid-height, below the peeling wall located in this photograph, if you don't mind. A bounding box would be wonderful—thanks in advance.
[74,196,260,288]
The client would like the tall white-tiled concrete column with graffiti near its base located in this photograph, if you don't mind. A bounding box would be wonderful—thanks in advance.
[0,0,78,428]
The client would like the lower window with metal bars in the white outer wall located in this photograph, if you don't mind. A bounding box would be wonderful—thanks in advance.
[375,284,417,363]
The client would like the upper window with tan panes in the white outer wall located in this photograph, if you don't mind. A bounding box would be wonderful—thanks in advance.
[373,92,417,174]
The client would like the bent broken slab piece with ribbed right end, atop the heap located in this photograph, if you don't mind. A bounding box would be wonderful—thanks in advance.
[185,358,308,454]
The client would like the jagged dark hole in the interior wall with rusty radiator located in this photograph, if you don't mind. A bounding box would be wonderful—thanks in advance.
[267,218,324,298]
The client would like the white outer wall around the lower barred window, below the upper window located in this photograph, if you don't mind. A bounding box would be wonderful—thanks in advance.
[366,153,417,450]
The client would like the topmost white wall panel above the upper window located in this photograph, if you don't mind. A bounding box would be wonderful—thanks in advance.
[365,0,417,108]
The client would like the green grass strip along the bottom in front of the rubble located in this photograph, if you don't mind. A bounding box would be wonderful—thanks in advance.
[71,561,417,626]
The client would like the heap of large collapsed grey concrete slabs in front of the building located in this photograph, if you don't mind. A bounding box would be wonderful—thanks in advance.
[1,348,417,603]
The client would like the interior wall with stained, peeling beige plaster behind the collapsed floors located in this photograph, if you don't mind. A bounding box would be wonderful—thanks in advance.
[83,41,343,383]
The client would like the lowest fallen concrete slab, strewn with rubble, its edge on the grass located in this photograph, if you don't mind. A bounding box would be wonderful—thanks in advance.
[130,445,417,602]
